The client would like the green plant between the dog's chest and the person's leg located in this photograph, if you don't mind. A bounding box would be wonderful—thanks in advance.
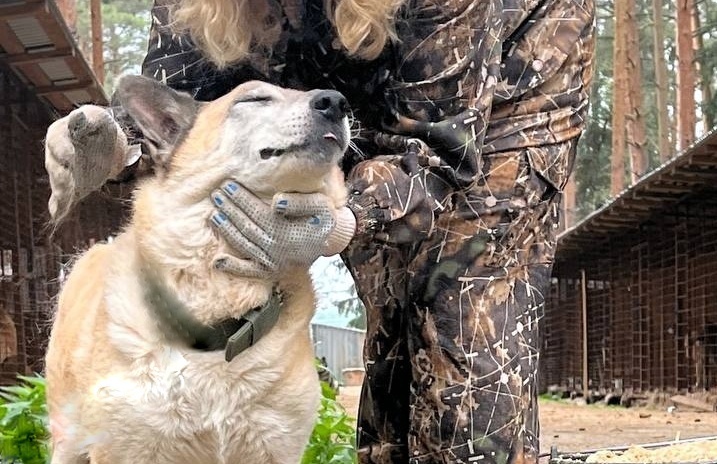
[301,382,357,464]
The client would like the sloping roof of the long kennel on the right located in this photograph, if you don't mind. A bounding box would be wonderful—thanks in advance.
[556,128,717,261]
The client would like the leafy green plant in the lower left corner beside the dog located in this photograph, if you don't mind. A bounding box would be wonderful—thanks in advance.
[0,375,50,464]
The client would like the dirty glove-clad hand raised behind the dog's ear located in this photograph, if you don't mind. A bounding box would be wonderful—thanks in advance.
[45,105,130,223]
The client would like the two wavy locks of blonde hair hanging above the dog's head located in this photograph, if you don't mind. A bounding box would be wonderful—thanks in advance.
[172,0,405,68]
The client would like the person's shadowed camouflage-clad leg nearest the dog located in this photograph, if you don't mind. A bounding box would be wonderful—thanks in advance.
[345,242,411,464]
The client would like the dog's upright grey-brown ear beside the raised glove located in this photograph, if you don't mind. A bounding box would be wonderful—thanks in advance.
[113,76,200,169]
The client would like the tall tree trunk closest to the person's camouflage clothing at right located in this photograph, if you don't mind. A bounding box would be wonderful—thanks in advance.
[610,1,629,196]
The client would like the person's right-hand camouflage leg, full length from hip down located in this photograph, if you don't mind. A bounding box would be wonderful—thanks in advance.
[398,0,594,458]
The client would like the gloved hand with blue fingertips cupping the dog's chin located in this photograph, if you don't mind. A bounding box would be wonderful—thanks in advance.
[207,181,356,279]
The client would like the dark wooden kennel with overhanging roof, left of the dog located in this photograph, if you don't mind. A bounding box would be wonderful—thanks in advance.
[0,0,119,384]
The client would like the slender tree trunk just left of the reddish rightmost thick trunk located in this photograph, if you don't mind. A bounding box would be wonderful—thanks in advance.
[652,0,672,163]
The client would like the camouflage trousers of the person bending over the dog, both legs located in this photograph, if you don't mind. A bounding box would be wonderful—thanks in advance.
[343,2,592,464]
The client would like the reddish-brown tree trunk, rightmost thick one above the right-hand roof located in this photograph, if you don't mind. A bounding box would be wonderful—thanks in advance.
[677,0,696,150]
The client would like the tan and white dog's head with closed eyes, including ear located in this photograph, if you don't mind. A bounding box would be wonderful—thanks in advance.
[115,76,349,199]
